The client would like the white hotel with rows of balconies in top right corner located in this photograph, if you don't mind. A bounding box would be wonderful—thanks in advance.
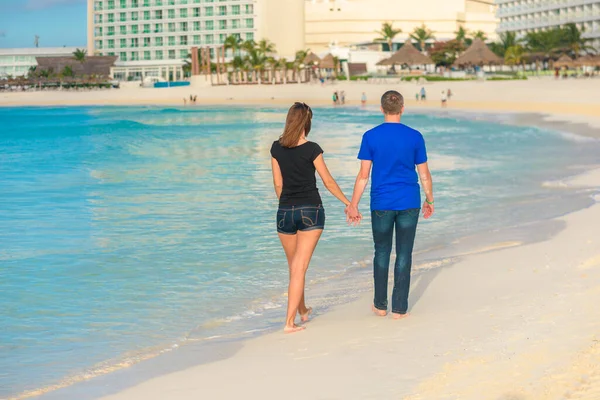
[496,0,600,49]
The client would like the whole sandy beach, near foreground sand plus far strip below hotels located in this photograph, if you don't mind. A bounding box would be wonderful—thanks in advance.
[7,78,600,400]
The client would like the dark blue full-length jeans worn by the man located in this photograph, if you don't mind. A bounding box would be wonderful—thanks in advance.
[371,208,420,314]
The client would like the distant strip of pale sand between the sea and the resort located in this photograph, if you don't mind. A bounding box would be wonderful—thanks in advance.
[0,77,600,122]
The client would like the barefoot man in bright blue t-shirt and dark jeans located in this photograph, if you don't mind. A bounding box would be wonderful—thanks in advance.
[346,91,434,319]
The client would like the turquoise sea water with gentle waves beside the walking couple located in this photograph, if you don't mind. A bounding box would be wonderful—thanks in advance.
[0,107,600,398]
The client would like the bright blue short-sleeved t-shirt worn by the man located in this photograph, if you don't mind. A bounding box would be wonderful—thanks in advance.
[358,122,427,211]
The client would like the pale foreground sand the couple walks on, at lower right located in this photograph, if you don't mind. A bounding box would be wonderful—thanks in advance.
[95,170,600,400]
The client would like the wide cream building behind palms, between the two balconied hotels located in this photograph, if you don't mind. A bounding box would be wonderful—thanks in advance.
[306,0,498,52]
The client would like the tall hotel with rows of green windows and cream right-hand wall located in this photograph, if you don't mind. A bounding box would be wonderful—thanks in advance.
[88,0,305,80]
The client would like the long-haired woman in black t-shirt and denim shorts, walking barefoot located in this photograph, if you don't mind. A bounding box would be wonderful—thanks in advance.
[271,103,350,333]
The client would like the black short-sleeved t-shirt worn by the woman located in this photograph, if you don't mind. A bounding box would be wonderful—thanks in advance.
[271,141,323,206]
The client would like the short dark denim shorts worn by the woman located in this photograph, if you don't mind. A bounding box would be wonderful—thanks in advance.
[277,204,325,235]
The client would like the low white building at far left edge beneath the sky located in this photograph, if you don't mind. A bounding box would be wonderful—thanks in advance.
[0,47,85,78]
